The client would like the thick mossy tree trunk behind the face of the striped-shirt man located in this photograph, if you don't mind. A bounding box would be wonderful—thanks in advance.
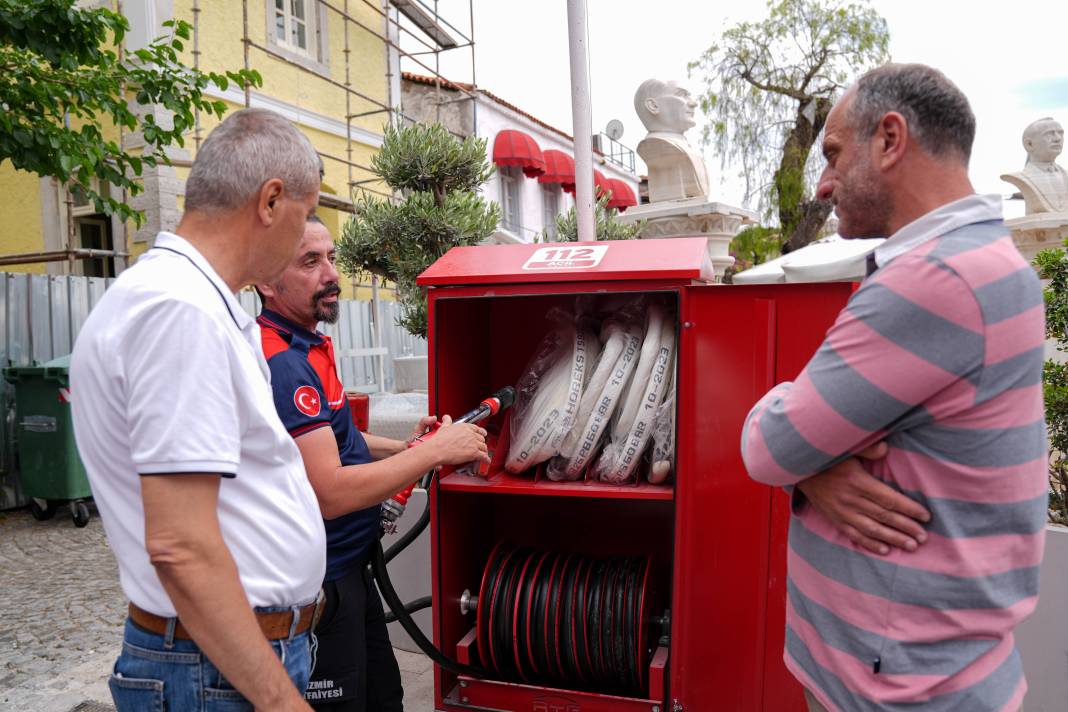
[774,96,833,252]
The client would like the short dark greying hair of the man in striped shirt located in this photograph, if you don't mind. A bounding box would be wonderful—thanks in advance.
[849,64,975,165]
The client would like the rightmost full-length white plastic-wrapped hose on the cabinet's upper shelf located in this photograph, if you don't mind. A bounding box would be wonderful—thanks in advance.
[594,305,675,485]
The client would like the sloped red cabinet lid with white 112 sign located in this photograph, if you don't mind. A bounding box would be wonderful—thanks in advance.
[419,237,712,286]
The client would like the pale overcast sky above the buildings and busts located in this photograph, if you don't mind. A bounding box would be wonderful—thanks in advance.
[405,0,1068,217]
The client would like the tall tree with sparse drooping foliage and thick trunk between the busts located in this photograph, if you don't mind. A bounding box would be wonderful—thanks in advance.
[690,0,890,249]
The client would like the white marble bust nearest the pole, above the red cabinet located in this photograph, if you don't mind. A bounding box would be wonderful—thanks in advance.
[634,79,708,203]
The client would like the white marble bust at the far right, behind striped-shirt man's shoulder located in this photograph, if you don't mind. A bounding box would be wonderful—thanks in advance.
[1002,116,1068,216]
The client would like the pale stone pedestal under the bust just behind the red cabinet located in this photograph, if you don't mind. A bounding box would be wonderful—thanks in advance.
[616,197,756,282]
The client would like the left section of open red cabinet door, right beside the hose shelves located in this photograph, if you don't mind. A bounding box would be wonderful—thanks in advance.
[671,287,774,712]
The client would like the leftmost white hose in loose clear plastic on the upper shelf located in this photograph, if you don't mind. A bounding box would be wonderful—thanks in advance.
[504,323,600,474]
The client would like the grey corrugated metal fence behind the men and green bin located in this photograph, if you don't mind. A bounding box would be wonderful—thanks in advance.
[0,272,426,509]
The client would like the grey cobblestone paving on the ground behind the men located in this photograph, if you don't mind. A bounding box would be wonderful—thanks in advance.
[0,509,434,712]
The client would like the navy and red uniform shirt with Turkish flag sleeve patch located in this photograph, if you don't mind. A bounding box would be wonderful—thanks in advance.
[257,308,381,581]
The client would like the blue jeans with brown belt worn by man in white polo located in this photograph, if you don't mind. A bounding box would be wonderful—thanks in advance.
[108,619,312,712]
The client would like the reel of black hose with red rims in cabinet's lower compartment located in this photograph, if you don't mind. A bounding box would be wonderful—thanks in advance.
[471,541,659,694]
